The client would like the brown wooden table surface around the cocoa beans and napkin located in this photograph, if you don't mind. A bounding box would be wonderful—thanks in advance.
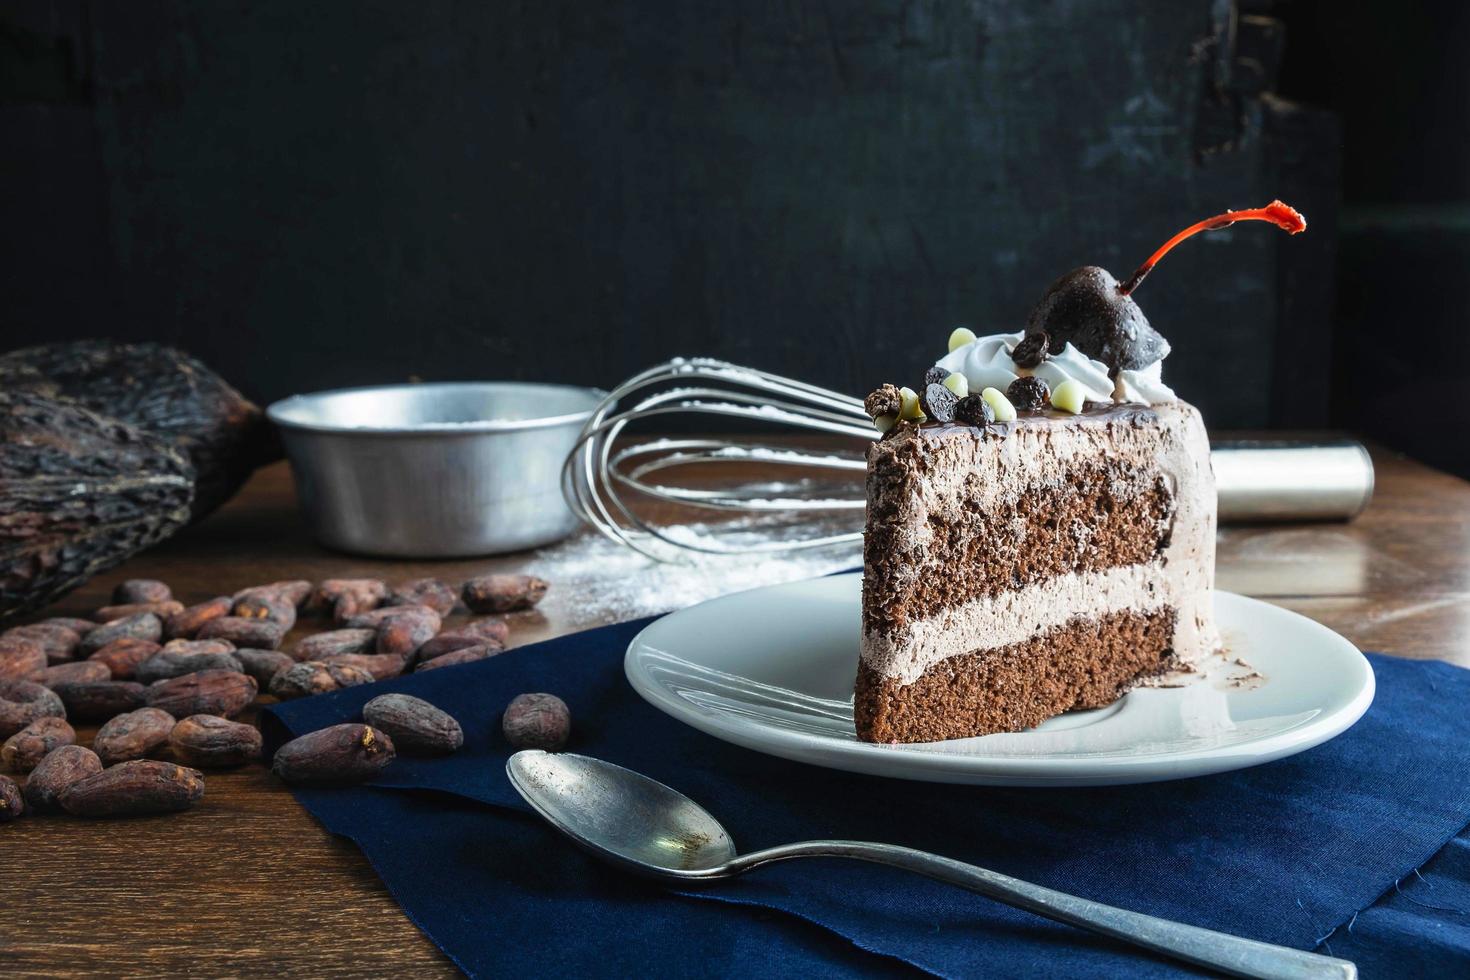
[0,453,1470,977]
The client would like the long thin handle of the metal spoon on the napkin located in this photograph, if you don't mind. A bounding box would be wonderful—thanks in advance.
[719,840,1358,980]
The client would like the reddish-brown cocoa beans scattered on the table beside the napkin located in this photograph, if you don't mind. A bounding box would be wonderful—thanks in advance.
[0,574,570,823]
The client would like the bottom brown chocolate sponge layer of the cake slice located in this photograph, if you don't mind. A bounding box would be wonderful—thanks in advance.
[854,608,1175,742]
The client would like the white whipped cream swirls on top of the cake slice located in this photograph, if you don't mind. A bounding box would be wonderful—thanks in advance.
[936,332,1176,406]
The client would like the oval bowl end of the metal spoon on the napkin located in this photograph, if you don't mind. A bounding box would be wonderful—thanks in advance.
[506,749,735,877]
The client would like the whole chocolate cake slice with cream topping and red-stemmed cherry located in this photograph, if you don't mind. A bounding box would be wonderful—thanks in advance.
[854,201,1305,742]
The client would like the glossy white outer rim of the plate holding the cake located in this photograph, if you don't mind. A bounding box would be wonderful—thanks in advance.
[623,570,1377,788]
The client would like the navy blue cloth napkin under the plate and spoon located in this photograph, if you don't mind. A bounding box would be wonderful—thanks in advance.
[263,587,1470,977]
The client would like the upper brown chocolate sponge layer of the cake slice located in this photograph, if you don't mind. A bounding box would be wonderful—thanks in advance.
[863,461,1175,629]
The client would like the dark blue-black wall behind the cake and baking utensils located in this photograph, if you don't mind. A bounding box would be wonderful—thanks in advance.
[0,0,1464,470]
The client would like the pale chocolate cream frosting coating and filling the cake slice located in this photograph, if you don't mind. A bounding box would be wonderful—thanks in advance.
[861,401,1220,683]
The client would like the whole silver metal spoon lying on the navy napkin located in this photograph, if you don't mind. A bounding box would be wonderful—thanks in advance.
[506,749,1358,980]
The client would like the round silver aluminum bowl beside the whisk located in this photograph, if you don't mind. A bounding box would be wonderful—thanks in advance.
[266,382,604,558]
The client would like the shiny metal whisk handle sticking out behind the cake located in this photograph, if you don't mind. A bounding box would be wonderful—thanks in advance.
[1210,439,1373,523]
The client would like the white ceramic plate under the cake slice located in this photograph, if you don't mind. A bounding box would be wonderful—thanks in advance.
[623,574,1373,786]
